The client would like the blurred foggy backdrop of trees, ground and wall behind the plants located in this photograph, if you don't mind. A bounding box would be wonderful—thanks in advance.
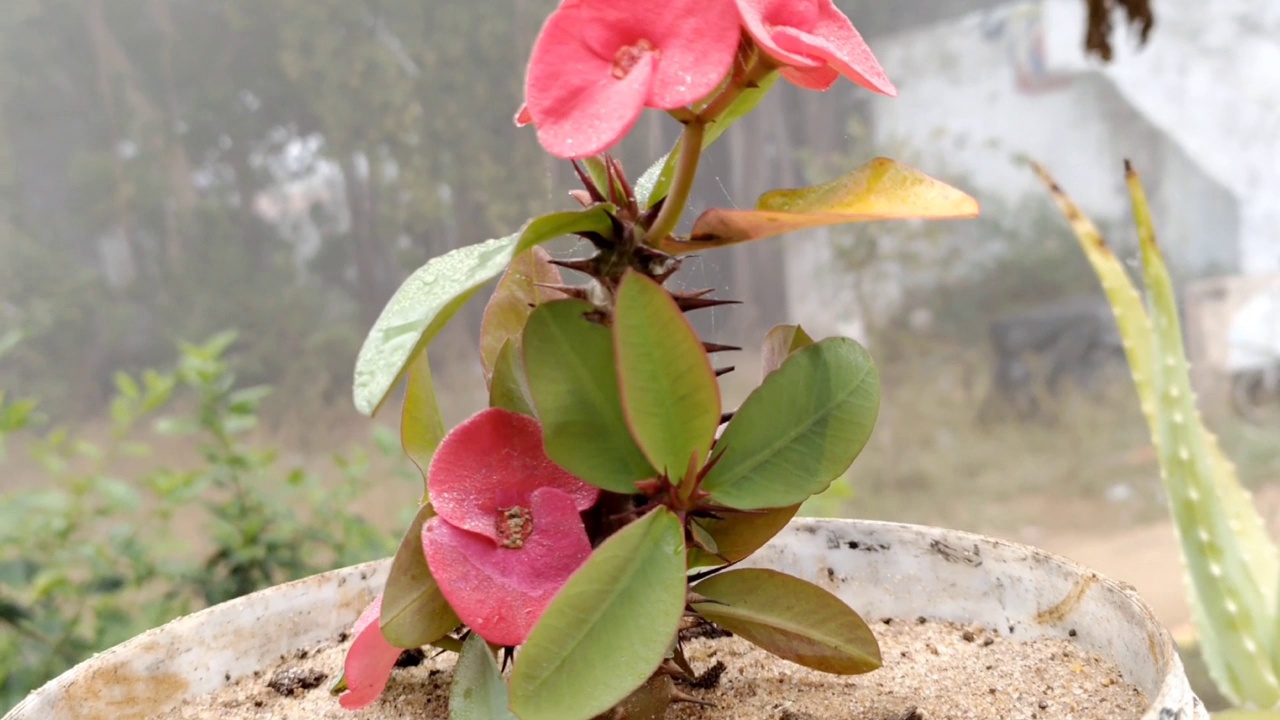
[0,0,1280,707]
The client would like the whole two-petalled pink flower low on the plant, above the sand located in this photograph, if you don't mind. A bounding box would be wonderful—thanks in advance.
[422,407,599,646]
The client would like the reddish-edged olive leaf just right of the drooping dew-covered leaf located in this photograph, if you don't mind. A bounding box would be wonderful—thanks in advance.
[480,247,564,382]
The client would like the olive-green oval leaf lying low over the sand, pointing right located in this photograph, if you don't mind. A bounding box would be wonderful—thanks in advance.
[692,569,881,675]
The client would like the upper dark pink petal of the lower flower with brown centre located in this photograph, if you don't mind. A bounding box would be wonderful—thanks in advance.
[428,407,600,541]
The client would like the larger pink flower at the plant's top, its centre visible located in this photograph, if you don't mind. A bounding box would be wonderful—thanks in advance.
[522,0,741,158]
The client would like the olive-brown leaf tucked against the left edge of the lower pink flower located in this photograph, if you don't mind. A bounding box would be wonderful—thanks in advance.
[379,505,461,648]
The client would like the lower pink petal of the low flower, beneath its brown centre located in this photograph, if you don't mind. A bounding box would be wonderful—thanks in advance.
[422,488,591,646]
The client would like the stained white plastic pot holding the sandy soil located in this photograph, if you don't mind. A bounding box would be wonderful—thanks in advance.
[3,519,1208,720]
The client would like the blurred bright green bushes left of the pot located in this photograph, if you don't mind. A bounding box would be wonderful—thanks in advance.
[0,333,420,712]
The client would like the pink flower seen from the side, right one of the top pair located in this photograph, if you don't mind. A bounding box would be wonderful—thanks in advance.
[736,0,897,96]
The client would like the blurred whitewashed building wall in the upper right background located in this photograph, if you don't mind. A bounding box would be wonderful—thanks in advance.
[787,0,1259,337]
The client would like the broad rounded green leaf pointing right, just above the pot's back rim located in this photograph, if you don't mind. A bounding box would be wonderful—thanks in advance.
[701,337,879,510]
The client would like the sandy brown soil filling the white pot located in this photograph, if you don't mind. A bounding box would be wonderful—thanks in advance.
[151,609,1147,720]
